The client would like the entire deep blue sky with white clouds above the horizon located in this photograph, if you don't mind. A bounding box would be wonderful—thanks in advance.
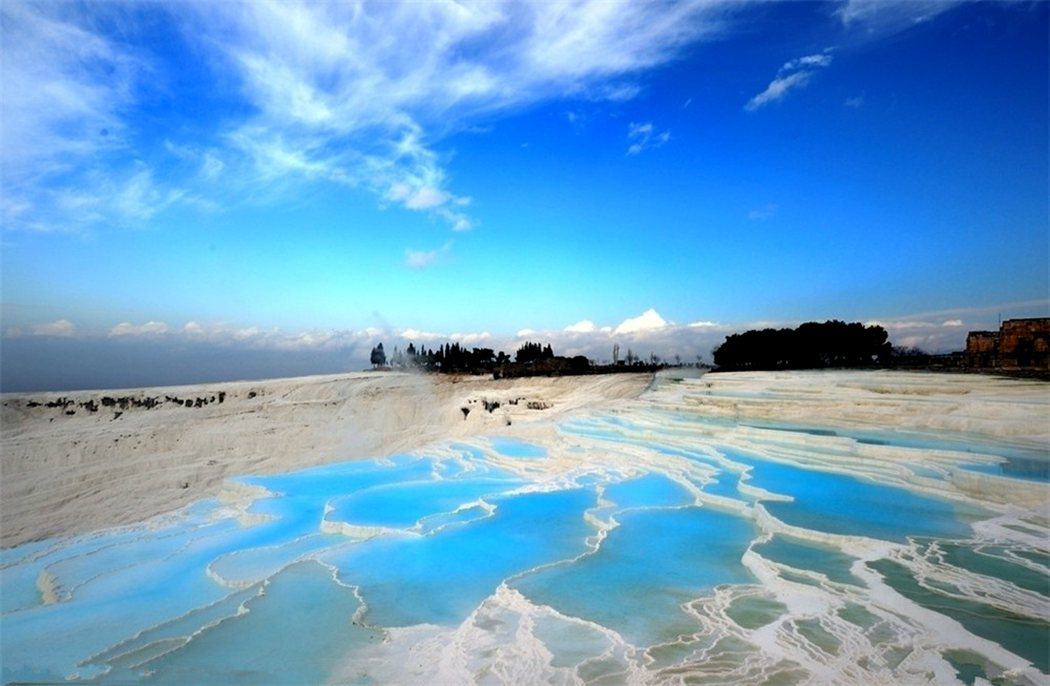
[0,0,1050,384]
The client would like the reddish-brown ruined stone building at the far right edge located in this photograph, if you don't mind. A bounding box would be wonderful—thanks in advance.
[964,317,1050,371]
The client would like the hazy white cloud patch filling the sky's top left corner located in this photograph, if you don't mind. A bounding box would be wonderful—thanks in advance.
[0,2,182,230]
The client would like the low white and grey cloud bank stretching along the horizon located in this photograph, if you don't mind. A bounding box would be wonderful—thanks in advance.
[8,299,1050,392]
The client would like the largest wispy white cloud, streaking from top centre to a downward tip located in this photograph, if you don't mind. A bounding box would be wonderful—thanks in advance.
[178,0,728,231]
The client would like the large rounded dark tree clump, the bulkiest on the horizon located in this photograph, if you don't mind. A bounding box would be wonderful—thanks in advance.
[714,319,893,370]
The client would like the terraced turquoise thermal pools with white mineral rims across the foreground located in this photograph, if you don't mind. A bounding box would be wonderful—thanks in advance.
[0,383,1050,684]
